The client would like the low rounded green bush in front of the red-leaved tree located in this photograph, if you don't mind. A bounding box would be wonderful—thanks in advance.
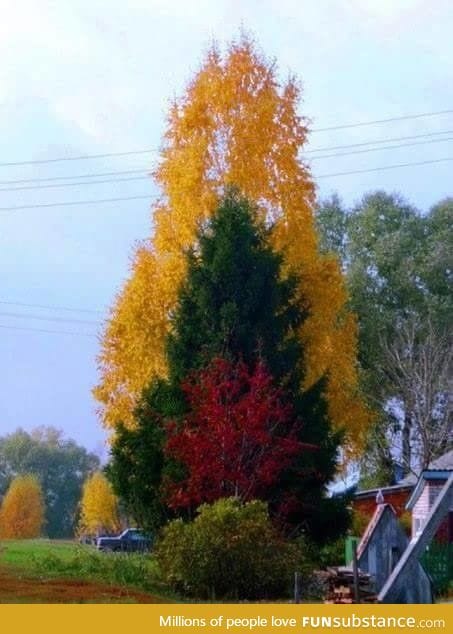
[155,498,304,600]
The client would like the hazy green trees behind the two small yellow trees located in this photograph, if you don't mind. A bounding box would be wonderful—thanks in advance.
[0,427,99,537]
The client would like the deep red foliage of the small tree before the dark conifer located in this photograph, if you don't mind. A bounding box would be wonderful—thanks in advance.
[166,358,308,508]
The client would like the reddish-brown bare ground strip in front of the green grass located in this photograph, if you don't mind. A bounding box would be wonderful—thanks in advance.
[0,567,163,603]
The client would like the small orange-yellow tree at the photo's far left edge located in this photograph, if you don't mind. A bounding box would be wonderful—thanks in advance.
[0,475,45,539]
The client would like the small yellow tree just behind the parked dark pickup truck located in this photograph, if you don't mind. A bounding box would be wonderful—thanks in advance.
[79,471,120,535]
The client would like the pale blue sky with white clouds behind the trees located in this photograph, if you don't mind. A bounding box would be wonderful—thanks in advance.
[0,0,453,456]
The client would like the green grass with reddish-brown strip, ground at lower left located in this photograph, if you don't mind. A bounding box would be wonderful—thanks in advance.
[0,539,175,603]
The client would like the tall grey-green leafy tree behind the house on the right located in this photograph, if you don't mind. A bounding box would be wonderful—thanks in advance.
[317,192,453,485]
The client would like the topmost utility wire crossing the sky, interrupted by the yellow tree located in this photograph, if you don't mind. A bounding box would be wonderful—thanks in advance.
[0,109,453,167]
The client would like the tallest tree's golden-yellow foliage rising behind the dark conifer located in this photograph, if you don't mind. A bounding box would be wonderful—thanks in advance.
[94,37,370,449]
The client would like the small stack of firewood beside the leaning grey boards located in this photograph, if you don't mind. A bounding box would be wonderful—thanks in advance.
[324,566,377,603]
